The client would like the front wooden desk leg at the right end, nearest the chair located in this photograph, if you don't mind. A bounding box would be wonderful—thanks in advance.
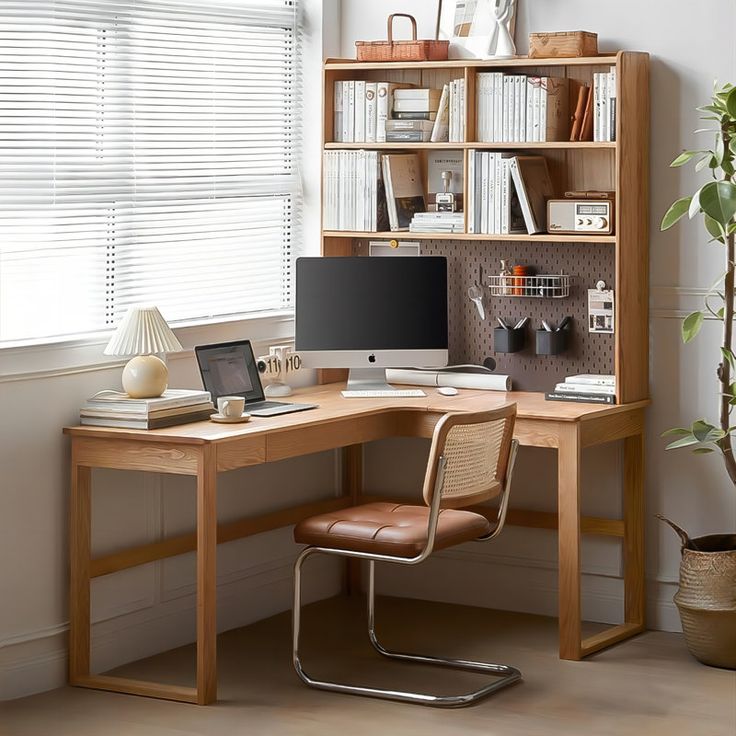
[557,422,582,660]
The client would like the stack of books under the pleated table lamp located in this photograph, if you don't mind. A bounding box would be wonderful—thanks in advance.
[79,388,215,429]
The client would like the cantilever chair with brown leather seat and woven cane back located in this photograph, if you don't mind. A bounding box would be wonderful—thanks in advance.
[292,404,521,707]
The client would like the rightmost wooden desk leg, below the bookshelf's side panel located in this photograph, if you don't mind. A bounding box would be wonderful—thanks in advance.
[623,434,646,628]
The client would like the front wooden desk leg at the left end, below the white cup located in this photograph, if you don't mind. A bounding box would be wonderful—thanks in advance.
[197,445,217,705]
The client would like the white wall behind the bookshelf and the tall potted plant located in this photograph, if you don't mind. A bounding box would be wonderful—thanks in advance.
[342,0,736,628]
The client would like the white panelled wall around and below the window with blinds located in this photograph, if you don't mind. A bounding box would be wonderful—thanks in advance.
[0,0,340,700]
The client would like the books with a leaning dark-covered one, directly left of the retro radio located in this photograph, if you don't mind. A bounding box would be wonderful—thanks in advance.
[467,150,554,235]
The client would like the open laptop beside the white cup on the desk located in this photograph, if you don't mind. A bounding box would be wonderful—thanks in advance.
[194,340,317,417]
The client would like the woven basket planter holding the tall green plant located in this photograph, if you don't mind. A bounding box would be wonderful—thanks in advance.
[659,516,736,669]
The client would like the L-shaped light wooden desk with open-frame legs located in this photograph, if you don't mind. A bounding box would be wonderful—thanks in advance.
[64,384,647,705]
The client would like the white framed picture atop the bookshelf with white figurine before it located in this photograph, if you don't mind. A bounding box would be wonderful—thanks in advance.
[437,0,518,59]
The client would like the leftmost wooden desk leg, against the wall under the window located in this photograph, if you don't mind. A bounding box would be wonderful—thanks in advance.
[69,462,92,685]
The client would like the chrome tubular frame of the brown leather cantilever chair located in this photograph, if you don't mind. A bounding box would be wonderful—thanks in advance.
[292,440,521,708]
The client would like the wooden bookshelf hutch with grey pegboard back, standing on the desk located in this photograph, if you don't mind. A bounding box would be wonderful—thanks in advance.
[322,51,649,403]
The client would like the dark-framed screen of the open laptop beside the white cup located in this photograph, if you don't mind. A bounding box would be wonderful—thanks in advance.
[194,340,263,403]
